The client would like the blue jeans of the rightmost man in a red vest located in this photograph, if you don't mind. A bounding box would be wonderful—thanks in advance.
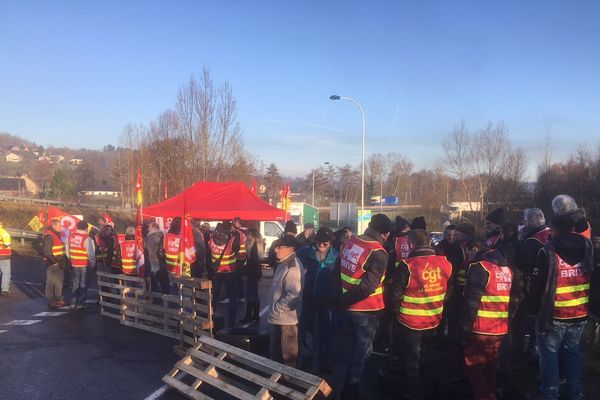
[537,321,585,400]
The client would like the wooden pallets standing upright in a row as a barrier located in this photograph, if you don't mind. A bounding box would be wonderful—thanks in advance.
[97,271,214,354]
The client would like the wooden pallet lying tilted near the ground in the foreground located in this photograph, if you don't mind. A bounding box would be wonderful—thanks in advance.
[162,336,331,400]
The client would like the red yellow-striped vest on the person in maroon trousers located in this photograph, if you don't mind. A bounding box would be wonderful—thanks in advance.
[469,261,512,336]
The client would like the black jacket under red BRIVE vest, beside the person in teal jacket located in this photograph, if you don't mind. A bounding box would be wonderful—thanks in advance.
[331,228,388,308]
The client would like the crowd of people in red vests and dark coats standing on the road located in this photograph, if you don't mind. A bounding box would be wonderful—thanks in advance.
[0,195,600,400]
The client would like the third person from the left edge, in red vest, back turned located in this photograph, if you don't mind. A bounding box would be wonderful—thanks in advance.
[67,221,96,309]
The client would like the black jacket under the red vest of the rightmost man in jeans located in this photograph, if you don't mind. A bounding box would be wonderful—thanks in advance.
[528,233,598,332]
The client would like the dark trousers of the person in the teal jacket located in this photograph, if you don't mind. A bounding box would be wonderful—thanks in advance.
[300,297,331,370]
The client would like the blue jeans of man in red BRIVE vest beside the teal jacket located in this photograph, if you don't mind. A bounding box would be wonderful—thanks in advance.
[341,310,380,386]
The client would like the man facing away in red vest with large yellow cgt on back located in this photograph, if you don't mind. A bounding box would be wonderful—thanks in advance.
[386,229,452,399]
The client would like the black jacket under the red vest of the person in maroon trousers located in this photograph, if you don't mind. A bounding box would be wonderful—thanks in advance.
[460,249,510,343]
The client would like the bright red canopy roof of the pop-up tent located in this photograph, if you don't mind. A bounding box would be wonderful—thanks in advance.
[143,182,285,221]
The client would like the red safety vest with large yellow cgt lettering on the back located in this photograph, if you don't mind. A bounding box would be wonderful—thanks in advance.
[398,256,452,330]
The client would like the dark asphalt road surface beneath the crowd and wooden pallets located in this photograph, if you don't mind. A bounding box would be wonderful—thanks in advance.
[0,256,600,400]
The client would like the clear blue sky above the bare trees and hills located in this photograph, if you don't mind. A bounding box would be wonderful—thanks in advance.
[0,0,600,176]
